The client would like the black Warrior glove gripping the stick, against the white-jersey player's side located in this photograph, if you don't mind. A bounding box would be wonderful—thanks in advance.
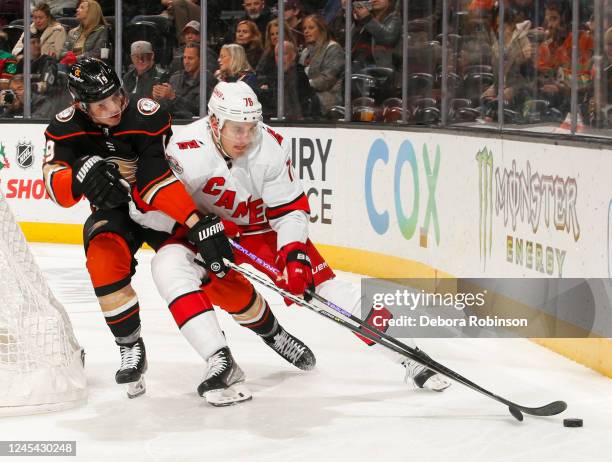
[187,214,234,278]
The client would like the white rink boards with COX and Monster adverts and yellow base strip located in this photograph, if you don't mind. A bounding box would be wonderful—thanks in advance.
[0,124,612,376]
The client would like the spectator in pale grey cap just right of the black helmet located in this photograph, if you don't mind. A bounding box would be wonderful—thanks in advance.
[123,40,166,99]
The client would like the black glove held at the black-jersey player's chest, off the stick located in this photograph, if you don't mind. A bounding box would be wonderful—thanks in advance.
[72,156,130,210]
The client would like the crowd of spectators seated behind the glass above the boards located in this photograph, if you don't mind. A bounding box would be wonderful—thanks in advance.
[0,0,612,132]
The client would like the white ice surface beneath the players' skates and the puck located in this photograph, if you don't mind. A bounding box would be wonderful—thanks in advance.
[0,244,612,462]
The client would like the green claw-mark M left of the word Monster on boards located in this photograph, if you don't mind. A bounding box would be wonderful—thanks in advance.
[476,148,493,270]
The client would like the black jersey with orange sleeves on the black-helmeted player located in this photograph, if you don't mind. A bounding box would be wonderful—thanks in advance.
[43,98,200,222]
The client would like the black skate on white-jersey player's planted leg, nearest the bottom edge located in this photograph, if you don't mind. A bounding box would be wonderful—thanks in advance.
[198,347,253,406]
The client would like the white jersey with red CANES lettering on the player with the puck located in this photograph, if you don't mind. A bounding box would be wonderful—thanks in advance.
[166,117,310,249]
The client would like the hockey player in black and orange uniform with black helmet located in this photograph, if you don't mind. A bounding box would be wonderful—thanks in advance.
[43,58,239,397]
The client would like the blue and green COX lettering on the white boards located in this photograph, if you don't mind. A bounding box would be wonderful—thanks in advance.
[365,139,440,247]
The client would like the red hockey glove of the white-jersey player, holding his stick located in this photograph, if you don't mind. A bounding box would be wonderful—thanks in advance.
[277,242,314,301]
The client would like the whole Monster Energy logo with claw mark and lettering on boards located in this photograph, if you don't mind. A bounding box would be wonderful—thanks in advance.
[476,147,580,277]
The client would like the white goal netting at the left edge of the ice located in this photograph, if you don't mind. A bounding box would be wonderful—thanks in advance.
[0,192,87,415]
